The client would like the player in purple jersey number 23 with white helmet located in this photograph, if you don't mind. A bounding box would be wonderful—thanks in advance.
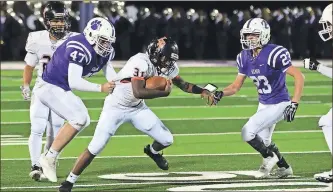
[213,18,304,178]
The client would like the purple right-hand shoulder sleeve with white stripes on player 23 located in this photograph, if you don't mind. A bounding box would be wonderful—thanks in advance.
[267,46,291,72]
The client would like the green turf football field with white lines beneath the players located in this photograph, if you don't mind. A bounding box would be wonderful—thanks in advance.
[1,67,332,191]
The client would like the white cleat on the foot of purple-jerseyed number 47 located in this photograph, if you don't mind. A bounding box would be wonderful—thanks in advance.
[39,153,58,182]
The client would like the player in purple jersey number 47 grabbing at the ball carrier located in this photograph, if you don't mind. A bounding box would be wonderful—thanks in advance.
[34,17,116,182]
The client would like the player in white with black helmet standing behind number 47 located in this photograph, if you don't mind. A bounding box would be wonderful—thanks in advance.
[21,1,77,181]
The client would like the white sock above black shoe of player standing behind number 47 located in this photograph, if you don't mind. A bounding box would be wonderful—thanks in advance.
[29,132,42,167]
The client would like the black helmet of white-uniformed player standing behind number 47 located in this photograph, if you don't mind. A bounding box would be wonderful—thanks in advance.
[42,1,70,39]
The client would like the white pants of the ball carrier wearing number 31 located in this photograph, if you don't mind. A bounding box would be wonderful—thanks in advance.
[88,94,173,155]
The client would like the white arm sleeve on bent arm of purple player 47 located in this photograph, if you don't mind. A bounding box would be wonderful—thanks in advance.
[68,63,101,92]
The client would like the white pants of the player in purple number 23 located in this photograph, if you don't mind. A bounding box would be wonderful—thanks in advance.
[242,101,290,147]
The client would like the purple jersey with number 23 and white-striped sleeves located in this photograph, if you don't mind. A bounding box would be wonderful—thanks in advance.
[237,44,291,104]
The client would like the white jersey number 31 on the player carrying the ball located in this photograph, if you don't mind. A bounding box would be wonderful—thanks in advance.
[112,53,179,107]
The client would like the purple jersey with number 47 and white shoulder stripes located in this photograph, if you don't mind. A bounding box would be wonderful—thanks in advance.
[42,34,115,91]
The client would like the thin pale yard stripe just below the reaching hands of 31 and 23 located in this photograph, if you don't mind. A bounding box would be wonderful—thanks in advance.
[1,101,332,113]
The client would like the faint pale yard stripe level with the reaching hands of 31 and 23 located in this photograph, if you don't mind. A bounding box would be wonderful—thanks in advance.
[1,93,332,101]
